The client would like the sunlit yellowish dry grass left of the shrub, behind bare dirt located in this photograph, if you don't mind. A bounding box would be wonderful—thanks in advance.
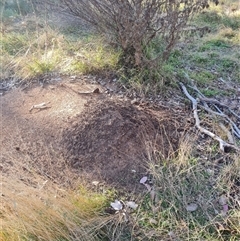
[0,17,120,82]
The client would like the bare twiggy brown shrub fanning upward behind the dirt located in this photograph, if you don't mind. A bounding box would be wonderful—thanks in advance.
[59,0,218,68]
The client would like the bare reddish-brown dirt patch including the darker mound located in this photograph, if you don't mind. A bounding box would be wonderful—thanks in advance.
[0,78,187,199]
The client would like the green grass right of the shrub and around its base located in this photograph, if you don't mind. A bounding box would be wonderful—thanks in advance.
[114,1,240,93]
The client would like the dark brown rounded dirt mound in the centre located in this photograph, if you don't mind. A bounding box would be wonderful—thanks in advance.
[62,99,180,190]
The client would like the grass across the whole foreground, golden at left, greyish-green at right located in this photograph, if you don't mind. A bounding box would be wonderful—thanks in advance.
[0,132,240,241]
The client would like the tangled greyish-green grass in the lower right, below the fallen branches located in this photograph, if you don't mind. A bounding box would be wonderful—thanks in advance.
[129,136,240,240]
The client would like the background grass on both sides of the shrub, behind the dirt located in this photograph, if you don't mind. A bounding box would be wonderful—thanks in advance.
[0,0,240,89]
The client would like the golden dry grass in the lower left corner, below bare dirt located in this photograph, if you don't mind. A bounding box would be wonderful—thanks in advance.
[0,177,108,241]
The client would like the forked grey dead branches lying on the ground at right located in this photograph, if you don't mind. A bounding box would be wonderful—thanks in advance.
[180,82,240,152]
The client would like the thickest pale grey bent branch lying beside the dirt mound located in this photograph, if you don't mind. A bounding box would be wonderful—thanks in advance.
[180,82,240,152]
